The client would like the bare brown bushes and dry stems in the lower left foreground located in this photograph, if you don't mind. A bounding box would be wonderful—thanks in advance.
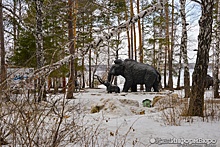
[0,86,138,147]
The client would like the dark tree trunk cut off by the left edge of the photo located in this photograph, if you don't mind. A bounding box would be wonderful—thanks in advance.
[0,0,9,101]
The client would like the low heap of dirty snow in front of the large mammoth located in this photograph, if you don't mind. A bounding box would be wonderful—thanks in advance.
[91,98,145,116]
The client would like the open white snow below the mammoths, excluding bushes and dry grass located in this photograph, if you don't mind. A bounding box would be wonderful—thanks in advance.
[64,85,220,147]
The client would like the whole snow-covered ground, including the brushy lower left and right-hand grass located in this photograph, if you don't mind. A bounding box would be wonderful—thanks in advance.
[0,80,220,147]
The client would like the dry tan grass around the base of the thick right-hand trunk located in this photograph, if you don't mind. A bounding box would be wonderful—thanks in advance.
[153,94,220,126]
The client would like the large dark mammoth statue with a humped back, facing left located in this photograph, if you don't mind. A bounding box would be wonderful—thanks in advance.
[108,59,161,92]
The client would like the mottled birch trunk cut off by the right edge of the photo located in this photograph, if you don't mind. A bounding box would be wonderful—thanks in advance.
[213,0,220,98]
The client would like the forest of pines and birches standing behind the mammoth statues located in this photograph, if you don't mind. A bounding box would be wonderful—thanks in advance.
[0,0,220,146]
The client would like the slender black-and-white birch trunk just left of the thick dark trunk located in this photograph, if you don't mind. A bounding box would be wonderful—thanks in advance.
[180,0,190,98]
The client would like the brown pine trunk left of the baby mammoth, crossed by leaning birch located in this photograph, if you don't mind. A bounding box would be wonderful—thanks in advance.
[66,0,75,99]
